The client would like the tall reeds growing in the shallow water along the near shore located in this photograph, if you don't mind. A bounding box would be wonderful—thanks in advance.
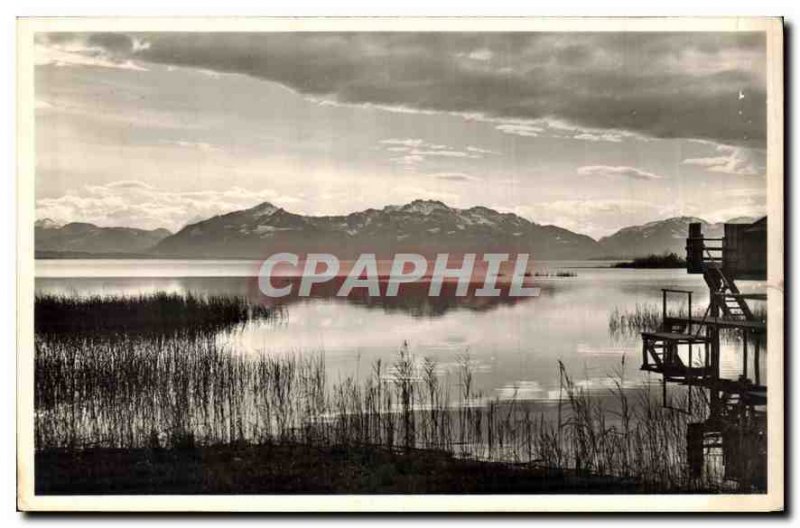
[34,297,764,492]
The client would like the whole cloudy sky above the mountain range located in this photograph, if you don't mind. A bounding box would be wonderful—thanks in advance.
[35,32,766,238]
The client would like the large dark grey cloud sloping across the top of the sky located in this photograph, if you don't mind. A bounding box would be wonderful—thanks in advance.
[39,32,766,146]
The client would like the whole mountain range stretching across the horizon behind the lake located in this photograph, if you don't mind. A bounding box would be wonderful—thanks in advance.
[35,200,755,260]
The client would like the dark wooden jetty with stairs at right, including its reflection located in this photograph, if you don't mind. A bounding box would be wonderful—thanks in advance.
[641,218,767,488]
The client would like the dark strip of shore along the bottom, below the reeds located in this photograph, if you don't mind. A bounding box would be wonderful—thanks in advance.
[35,444,654,495]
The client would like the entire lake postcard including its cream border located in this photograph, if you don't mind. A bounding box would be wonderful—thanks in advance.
[17,18,784,511]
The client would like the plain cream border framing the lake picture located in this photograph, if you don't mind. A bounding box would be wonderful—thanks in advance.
[17,18,784,512]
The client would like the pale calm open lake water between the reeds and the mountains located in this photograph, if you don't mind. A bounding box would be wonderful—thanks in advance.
[36,260,766,405]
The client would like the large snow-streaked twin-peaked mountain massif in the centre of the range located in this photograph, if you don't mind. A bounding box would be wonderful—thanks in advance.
[154,200,598,260]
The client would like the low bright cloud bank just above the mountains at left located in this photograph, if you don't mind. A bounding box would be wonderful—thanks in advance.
[36,180,296,231]
